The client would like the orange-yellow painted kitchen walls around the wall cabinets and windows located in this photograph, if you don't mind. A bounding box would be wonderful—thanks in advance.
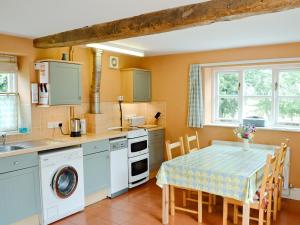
[0,32,300,188]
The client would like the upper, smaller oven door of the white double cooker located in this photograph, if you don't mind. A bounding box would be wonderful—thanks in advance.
[128,136,149,157]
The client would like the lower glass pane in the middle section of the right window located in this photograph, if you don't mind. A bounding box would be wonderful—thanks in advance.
[243,97,272,121]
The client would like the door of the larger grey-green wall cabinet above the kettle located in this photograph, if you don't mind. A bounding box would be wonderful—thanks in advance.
[49,62,82,105]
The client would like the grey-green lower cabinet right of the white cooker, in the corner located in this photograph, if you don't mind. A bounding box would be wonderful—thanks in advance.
[148,129,164,171]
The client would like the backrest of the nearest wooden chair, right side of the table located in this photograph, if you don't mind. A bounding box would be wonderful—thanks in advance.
[259,149,279,207]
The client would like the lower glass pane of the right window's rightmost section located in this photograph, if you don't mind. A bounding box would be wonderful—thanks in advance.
[279,97,300,123]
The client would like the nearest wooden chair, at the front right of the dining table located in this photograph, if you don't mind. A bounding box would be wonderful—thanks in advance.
[223,151,279,225]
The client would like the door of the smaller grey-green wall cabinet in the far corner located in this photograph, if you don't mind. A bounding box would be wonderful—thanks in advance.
[133,70,151,102]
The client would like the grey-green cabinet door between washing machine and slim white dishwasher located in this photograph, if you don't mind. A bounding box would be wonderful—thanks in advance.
[83,151,109,196]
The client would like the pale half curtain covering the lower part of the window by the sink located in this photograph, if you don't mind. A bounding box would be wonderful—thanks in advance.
[0,94,18,132]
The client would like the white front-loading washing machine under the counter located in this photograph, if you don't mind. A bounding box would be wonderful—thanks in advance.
[39,147,84,225]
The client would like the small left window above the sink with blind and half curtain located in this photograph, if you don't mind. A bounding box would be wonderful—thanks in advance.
[0,55,19,132]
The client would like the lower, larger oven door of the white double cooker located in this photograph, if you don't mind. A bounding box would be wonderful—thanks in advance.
[128,153,149,183]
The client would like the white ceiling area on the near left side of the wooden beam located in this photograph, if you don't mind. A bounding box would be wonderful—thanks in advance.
[0,0,204,38]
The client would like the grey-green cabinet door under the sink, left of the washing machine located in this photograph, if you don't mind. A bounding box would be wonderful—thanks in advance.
[0,167,40,225]
